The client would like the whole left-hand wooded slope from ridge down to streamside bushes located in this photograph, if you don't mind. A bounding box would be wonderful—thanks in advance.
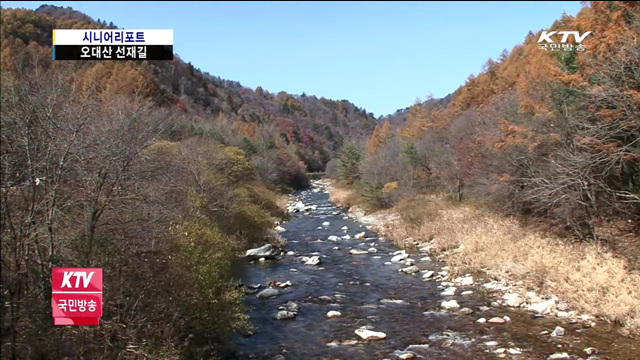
[0,6,375,359]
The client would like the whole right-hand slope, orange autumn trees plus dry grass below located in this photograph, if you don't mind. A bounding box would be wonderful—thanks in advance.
[327,1,640,336]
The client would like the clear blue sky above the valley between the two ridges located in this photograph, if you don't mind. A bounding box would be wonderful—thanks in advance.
[2,1,581,116]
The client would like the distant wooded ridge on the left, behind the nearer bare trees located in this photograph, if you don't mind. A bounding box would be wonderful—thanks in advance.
[2,5,376,176]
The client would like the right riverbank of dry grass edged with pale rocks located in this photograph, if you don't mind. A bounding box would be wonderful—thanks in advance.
[323,180,640,337]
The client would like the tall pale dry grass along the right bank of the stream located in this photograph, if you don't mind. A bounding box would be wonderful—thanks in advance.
[335,183,640,335]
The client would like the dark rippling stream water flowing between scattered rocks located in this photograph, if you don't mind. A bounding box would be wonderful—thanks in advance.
[231,182,640,360]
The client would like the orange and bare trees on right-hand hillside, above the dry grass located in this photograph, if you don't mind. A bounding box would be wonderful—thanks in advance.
[338,1,640,239]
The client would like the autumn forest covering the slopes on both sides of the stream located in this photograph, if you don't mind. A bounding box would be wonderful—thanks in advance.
[0,1,640,359]
